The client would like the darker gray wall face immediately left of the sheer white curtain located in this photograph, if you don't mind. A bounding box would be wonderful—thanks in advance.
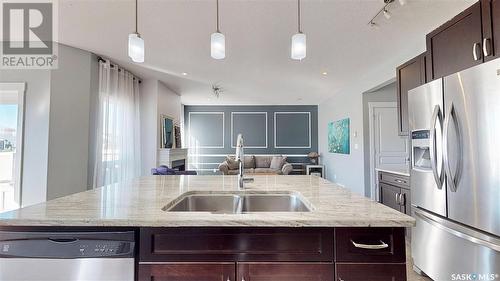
[47,46,93,200]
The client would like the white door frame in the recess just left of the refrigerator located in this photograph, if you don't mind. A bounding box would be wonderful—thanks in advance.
[368,102,398,202]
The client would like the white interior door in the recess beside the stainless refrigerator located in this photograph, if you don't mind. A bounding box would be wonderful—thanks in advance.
[369,102,409,200]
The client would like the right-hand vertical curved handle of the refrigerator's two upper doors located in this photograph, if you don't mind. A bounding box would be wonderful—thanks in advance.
[443,102,462,192]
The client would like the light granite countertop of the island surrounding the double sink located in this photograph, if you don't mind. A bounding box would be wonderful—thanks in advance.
[0,175,415,227]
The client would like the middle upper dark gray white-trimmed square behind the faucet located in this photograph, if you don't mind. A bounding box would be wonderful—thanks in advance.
[231,112,268,148]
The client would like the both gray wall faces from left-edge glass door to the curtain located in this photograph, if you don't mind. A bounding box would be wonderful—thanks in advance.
[0,45,98,206]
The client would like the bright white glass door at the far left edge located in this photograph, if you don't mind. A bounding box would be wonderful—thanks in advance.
[0,83,25,212]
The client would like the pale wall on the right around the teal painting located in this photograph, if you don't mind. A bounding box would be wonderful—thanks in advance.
[318,55,410,195]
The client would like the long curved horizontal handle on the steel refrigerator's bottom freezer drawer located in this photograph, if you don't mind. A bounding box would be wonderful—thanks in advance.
[414,208,500,251]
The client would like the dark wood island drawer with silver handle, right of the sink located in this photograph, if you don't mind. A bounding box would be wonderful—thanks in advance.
[335,227,405,263]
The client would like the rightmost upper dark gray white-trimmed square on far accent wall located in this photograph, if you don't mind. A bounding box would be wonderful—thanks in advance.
[274,112,311,148]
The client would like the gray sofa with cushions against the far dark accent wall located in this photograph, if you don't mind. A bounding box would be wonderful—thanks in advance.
[219,155,293,175]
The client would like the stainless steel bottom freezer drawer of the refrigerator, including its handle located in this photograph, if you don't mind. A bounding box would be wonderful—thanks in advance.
[412,209,500,280]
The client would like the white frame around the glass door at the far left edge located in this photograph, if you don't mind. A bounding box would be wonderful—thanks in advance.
[0,82,26,208]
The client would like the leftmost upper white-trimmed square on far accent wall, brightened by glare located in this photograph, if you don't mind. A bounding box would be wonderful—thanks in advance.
[188,112,225,149]
